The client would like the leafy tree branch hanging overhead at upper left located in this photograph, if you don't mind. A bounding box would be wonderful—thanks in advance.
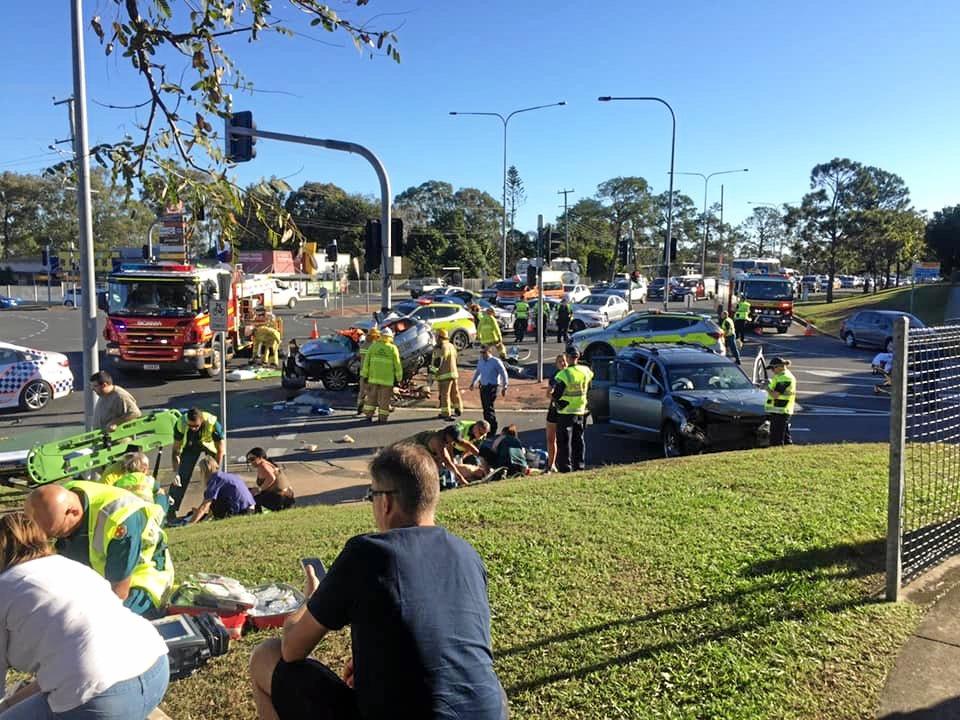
[83,0,400,248]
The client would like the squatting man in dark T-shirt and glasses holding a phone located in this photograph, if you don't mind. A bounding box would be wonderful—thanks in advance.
[250,443,508,720]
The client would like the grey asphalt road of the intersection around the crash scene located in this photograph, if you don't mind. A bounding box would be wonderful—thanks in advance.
[0,301,889,476]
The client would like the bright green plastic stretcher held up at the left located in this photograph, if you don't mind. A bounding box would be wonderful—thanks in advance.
[27,410,181,485]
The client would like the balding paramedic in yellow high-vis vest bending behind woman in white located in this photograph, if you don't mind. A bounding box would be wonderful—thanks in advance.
[26,480,173,619]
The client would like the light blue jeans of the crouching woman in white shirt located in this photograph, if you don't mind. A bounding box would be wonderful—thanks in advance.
[0,655,170,720]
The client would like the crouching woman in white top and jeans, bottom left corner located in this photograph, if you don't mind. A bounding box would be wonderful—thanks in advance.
[0,512,170,720]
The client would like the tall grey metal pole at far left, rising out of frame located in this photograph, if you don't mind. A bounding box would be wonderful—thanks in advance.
[70,0,100,430]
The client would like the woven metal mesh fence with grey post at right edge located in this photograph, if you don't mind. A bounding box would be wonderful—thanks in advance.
[887,319,960,600]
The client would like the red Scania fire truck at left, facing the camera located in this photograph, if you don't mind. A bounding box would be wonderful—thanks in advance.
[103,263,273,377]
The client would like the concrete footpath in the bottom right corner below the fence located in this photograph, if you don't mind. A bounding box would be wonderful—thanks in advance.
[877,558,960,720]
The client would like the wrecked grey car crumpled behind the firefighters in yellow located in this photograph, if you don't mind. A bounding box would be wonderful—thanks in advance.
[295,317,434,390]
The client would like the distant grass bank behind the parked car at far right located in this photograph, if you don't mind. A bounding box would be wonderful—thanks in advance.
[796,284,953,335]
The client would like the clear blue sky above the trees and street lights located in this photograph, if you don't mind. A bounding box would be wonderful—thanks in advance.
[0,0,960,229]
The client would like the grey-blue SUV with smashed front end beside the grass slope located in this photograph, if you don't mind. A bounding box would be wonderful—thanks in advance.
[590,345,770,457]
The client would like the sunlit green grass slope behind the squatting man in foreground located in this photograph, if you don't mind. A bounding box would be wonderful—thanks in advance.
[163,445,922,720]
